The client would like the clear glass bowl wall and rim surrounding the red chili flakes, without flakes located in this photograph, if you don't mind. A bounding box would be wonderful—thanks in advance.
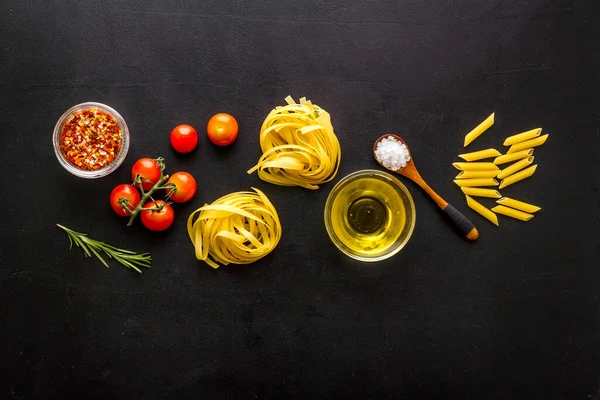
[52,102,129,179]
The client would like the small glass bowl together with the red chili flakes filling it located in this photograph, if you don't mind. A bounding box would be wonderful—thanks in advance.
[53,102,129,179]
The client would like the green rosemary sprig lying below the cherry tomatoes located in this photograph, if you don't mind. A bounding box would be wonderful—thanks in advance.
[56,224,152,273]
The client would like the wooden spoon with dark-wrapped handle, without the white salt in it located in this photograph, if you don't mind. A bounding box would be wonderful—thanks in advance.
[373,134,479,241]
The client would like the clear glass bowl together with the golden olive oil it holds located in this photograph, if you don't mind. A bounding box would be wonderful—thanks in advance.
[325,169,415,261]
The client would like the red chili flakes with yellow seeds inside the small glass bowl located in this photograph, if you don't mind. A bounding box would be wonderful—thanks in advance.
[60,108,123,171]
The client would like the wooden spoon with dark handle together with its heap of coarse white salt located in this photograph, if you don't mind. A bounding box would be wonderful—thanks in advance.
[373,134,479,241]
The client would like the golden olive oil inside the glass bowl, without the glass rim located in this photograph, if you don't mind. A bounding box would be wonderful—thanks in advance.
[331,175,406,257]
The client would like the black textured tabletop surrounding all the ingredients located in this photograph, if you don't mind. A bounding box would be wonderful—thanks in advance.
[0,0,600,399]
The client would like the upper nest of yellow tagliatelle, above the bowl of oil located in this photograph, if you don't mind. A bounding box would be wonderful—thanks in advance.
[248,96,341,189]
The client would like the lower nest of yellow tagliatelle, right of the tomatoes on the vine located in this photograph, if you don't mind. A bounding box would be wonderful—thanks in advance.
[187,188,281,268]
